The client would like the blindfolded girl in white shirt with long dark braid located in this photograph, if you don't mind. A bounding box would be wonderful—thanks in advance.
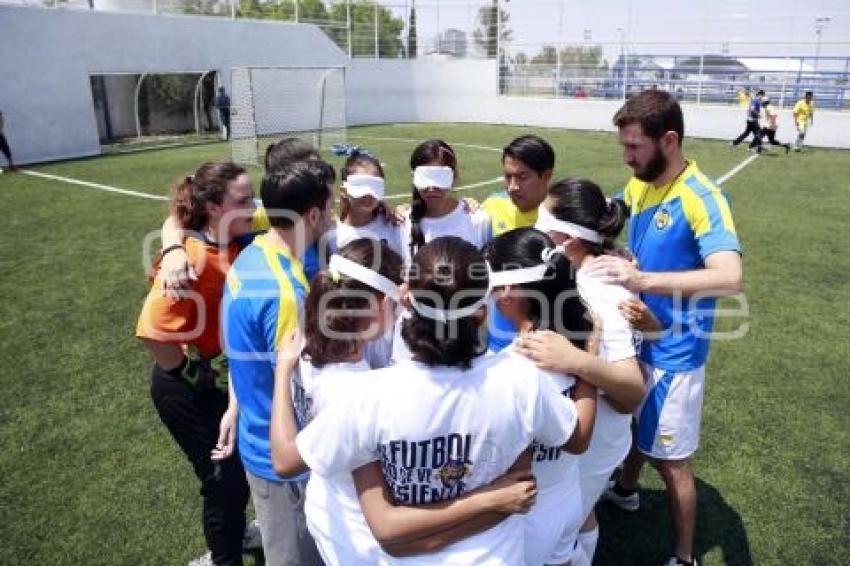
[402,140,489,265]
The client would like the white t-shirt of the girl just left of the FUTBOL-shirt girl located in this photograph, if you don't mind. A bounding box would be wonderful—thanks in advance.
[293,360,384,566]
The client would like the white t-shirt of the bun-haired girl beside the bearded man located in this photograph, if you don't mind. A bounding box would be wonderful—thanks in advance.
[576,269,637,482]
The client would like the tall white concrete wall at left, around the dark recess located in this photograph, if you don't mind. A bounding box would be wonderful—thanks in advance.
[0,5,347,163]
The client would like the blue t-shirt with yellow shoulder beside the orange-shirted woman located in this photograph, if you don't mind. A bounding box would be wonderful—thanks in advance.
[221,235,309,482]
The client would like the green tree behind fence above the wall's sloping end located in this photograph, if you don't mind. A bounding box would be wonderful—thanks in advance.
[326,0,404,58]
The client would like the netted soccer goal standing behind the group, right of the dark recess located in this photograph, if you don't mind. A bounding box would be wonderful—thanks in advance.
[230,67,346,164]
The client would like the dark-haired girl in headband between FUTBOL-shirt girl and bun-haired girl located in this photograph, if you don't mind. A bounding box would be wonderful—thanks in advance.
[485,228,597,566]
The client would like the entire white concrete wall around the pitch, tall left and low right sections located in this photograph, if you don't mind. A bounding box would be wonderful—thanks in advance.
[0,12,850,163]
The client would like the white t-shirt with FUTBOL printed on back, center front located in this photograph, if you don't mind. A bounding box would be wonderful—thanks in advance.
[296,354,576,565]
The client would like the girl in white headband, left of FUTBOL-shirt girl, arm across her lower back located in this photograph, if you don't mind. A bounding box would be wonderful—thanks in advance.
[270,239,536,566]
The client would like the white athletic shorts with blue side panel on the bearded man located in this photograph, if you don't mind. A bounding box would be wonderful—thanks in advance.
[636,362,705,460]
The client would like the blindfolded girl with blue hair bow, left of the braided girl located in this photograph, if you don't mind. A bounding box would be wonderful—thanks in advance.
[326,153,402,254]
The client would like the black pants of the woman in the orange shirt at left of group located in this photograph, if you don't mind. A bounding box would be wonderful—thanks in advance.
[151,366,250,566]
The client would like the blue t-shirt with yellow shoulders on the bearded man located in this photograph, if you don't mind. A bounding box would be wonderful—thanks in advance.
[623,162,741,371]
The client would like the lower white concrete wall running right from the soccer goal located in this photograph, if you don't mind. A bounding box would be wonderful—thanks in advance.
[348,60,850,148]
